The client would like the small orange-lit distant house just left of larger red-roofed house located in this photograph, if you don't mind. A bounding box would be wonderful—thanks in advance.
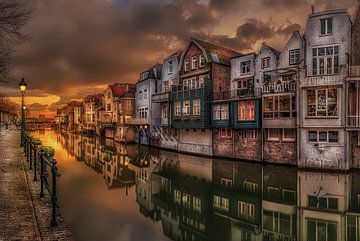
[82,94,103,134]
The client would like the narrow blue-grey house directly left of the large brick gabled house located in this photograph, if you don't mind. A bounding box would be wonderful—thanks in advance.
[152,51,182,150]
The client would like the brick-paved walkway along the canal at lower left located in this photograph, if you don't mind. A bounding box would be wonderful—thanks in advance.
[0,126,73,241]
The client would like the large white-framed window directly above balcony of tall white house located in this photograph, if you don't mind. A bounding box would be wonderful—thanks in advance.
[312,46,339,75]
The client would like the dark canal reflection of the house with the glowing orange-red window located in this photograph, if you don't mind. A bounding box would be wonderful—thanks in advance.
[211,160,262,241]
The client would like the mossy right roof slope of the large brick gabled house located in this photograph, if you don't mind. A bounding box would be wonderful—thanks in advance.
[189,38,241,65]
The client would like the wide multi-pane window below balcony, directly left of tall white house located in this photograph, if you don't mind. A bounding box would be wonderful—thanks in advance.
[263,95,296,118]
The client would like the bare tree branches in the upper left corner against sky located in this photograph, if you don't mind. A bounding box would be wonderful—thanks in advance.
[0,0,32,82]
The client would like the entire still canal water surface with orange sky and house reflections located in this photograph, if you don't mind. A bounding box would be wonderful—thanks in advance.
[34,130,360,241]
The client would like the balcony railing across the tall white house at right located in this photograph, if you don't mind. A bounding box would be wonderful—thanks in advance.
[301,68,346,87]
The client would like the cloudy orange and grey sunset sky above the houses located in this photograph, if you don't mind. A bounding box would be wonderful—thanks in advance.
[0,0,357,115]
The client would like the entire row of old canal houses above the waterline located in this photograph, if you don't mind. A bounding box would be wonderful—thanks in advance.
[58,6,360,170]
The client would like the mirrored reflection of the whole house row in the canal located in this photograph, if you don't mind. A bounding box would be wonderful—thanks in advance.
[59,133,360,241]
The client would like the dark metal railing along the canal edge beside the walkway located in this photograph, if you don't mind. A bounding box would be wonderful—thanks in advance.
[24,135,60,227]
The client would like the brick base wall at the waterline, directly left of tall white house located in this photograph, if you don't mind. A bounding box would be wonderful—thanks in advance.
[264,141,297,165]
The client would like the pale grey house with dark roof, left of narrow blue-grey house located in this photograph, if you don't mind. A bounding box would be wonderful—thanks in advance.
[129,64,162,145]
